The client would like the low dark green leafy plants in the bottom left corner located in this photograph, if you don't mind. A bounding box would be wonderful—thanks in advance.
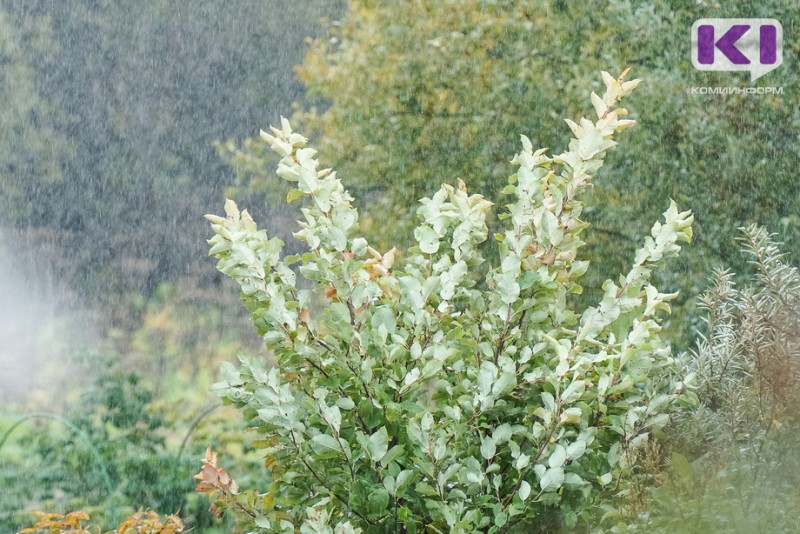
[0,373,203,532]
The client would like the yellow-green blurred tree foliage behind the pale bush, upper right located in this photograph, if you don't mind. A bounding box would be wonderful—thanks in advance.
[222,0,800,346]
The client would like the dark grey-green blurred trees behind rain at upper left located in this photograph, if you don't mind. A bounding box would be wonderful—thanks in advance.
[0,0,340,314]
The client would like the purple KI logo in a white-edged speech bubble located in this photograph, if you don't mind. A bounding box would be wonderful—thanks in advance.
[692,19,783,81]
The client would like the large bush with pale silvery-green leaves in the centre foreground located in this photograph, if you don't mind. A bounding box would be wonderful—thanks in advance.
[205,72,692,533]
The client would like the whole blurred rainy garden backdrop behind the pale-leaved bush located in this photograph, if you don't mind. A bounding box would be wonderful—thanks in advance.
[0,0,800,532]
